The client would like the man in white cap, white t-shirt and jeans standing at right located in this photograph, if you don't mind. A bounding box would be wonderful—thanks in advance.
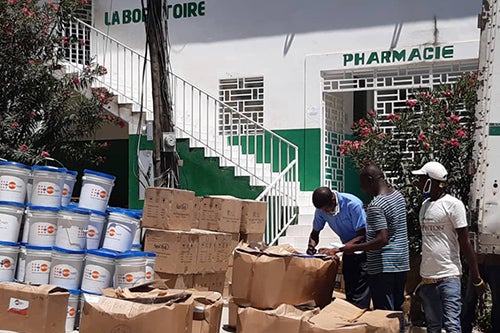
[412,162,486,333]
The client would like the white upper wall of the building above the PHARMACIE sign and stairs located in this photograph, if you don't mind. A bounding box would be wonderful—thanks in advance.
[94,0,481,129]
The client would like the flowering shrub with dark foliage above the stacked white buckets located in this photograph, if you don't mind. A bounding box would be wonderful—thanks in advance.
[0,0,118,164]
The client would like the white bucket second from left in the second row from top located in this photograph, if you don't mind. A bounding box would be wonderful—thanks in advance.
[26,206,59,246]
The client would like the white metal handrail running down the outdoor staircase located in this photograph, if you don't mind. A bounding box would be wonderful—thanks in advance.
[62,19,299,244]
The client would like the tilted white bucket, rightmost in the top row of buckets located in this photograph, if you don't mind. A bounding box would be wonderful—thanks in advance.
[78,169,116,213]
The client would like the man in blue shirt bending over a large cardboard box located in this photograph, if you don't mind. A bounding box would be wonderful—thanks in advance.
[307,187,370,308]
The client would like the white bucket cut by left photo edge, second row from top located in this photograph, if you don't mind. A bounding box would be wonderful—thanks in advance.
[0,201,24,243]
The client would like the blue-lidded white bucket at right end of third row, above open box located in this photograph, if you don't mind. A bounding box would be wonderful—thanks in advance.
[113,251,146,288]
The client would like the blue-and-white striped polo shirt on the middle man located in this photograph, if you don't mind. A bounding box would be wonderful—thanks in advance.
[366,191,410,274]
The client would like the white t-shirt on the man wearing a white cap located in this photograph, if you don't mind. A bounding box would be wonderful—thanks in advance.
[419,194,467,279]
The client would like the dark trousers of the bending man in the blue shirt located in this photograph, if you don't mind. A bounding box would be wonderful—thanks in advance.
[342,252,370,309]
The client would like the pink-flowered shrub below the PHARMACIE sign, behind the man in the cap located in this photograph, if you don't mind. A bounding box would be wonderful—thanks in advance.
[339,73,479,251]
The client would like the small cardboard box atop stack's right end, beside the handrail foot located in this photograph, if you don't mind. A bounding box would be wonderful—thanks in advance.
[240,200,267,234]
